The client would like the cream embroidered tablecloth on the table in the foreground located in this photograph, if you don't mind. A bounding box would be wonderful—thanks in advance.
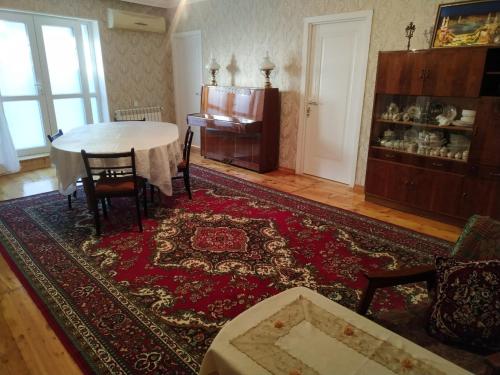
[200,287,470,375]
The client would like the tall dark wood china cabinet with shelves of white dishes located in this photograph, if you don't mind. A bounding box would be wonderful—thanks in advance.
[365,47,500,223]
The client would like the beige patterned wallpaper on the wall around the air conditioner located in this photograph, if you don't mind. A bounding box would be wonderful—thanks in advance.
[0,0,175,121]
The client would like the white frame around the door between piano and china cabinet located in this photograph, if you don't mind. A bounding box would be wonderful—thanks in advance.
[295,9,373,187]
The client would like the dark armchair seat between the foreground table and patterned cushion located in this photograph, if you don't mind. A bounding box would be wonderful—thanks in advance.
[374,303,489,375]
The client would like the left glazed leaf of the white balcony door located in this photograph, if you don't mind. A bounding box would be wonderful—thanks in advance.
[0,12,51,156]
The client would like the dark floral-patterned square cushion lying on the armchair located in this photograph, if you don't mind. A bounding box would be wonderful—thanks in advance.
[428,257,500,352]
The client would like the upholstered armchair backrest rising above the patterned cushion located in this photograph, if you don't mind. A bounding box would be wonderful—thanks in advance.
[451,215,500,260]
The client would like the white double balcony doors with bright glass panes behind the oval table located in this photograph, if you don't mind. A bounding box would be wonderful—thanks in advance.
[0,12,103,156]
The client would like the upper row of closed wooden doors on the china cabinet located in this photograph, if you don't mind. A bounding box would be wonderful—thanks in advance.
[375,47,487,97]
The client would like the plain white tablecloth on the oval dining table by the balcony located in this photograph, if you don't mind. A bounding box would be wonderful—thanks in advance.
[50,121,182,195]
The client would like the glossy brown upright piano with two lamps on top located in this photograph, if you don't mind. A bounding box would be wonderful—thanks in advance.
[187,86,280,173]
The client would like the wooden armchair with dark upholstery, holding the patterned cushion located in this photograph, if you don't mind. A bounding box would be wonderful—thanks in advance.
[357,216,500,375]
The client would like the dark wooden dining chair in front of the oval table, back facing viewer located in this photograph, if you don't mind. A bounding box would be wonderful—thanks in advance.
[82,148,148,236]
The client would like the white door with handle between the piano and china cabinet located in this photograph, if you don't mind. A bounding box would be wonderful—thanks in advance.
[302,12,371,185]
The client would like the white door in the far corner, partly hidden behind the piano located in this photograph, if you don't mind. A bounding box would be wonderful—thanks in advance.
[172,31,202,146]
